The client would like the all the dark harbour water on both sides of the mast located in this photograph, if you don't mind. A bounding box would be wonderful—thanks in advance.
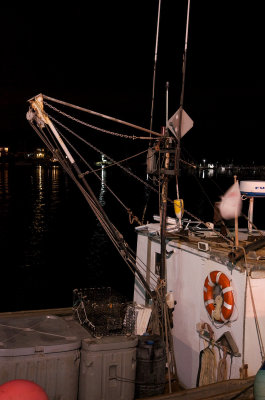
[0,164,265,311]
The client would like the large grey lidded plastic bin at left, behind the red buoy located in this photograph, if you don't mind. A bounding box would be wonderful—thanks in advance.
[0,315,89,400]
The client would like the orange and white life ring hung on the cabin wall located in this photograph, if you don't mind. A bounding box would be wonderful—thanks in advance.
[203,271,235,323]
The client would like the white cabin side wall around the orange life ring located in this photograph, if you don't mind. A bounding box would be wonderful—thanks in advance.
[167,244,245,388]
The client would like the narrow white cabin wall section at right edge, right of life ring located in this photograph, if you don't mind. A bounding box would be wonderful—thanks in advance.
[242,278,265,376]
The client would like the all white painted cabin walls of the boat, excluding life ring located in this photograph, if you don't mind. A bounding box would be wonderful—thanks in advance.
[134,233,256,388]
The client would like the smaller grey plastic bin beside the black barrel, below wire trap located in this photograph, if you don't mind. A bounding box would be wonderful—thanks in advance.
[78,336,138,400]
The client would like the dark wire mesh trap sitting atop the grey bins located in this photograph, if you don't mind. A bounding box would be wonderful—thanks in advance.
[73,287,136,337]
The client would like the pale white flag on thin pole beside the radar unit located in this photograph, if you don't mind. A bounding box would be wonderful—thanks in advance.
[219,181,242,219]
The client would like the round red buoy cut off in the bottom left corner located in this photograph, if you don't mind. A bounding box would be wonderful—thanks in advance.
[0,379,49,400]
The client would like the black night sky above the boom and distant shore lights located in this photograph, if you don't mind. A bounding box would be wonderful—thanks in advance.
[0,0,265,163]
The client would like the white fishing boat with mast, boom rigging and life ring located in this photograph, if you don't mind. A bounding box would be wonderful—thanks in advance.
[2,2,265,400]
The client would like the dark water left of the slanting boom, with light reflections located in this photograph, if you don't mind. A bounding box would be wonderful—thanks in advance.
[0,165,136,311]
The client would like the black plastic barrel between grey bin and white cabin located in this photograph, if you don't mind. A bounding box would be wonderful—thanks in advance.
[135,335,166,398]
